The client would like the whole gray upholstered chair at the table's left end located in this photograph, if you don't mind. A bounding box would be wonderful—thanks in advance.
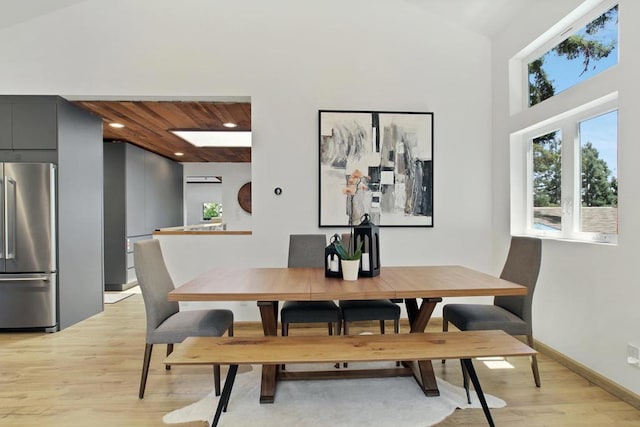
[133,240,233,399]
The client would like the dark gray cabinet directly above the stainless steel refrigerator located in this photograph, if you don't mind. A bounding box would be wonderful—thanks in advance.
[0,96,59,150]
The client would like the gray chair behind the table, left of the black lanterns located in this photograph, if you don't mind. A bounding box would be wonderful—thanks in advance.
[280,234,342,336]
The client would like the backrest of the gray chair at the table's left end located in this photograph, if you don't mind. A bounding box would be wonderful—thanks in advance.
[133,239,180,338]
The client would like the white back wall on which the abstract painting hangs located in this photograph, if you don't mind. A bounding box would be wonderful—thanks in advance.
[0,0,492,332]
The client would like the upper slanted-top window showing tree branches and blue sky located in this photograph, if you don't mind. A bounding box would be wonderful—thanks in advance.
[527,5,618,107]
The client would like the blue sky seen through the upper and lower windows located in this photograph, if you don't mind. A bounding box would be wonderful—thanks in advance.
[528,7,618,176]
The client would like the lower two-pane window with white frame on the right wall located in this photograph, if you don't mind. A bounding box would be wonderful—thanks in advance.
[516,97,618,242]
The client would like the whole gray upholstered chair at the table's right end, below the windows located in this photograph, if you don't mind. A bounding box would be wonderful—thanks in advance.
[442,237,542,387]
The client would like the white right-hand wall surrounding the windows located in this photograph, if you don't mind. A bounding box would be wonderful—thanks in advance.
[493,0,640,393]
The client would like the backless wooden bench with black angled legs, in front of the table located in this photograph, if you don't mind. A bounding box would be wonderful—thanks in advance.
[165,331,536,426]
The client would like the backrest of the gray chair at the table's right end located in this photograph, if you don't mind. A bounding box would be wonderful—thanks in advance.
[494,236,542,329]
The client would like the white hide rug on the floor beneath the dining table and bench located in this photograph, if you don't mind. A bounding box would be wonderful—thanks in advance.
[163,363,506,427]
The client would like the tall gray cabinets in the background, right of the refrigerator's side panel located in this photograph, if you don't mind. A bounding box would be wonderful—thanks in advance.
[103,141,183,291]
